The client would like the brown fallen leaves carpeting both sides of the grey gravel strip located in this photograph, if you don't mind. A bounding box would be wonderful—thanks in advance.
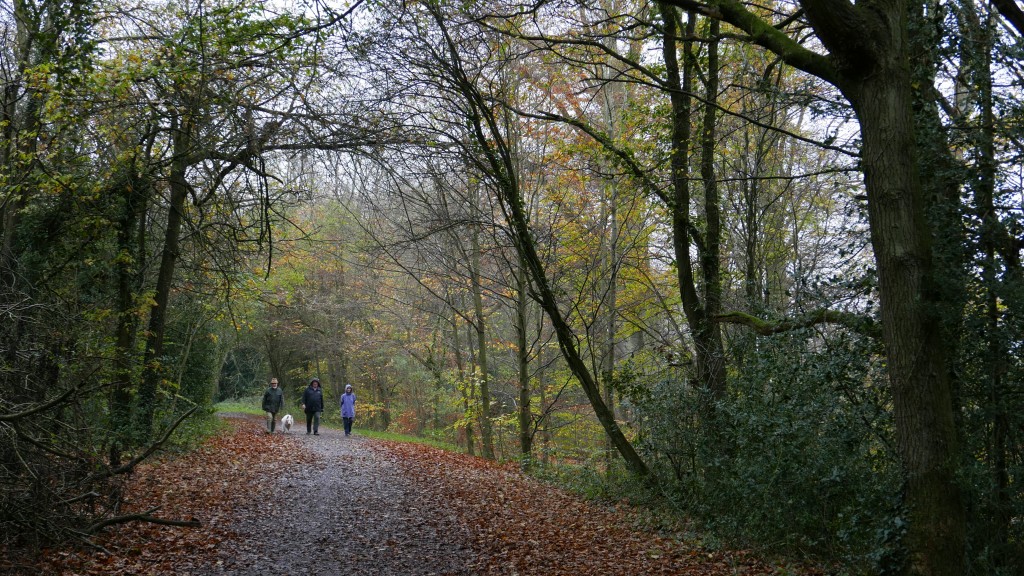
[8,418,817,576]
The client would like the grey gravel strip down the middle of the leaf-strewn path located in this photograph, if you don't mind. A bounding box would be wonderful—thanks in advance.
[189,418,473,576]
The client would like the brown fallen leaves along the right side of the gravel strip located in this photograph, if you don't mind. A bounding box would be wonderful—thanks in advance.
[372,442,815,576]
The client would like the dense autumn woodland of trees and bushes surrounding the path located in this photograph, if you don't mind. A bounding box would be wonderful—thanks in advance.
[0,0,1024,575]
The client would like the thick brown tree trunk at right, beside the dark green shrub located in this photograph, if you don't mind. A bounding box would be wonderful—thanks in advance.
[841,30,966,576]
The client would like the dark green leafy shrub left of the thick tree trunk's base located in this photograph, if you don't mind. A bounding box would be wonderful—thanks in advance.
[635,327,898,568]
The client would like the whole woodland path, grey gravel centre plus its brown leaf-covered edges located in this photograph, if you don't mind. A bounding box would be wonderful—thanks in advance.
[25,416,822,576]
